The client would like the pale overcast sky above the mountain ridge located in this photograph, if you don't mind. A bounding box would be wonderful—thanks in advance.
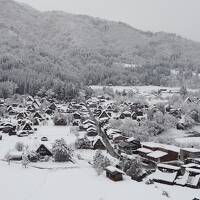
[16,0,200,41]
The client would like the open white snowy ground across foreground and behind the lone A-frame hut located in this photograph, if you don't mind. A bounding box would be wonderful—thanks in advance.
[0,124,200,200]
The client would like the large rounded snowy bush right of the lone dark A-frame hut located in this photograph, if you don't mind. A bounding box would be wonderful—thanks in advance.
[52,138,73,162]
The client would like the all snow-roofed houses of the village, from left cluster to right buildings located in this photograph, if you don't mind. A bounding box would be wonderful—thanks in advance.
[0,92,200,188]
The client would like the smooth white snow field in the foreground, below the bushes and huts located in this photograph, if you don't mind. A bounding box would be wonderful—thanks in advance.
[0,161,200,200]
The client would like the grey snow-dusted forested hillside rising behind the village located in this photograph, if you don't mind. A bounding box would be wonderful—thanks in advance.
[0,0,200,98]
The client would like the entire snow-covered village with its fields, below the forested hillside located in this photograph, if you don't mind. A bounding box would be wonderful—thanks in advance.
[0,86,200,200]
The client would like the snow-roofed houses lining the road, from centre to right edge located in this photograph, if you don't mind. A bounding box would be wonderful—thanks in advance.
[67,97,200,188]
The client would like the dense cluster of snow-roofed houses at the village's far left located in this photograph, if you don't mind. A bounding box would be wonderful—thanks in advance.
[0,96,60,137]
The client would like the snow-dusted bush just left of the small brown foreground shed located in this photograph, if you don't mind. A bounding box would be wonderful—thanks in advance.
[93,150,110,175]
